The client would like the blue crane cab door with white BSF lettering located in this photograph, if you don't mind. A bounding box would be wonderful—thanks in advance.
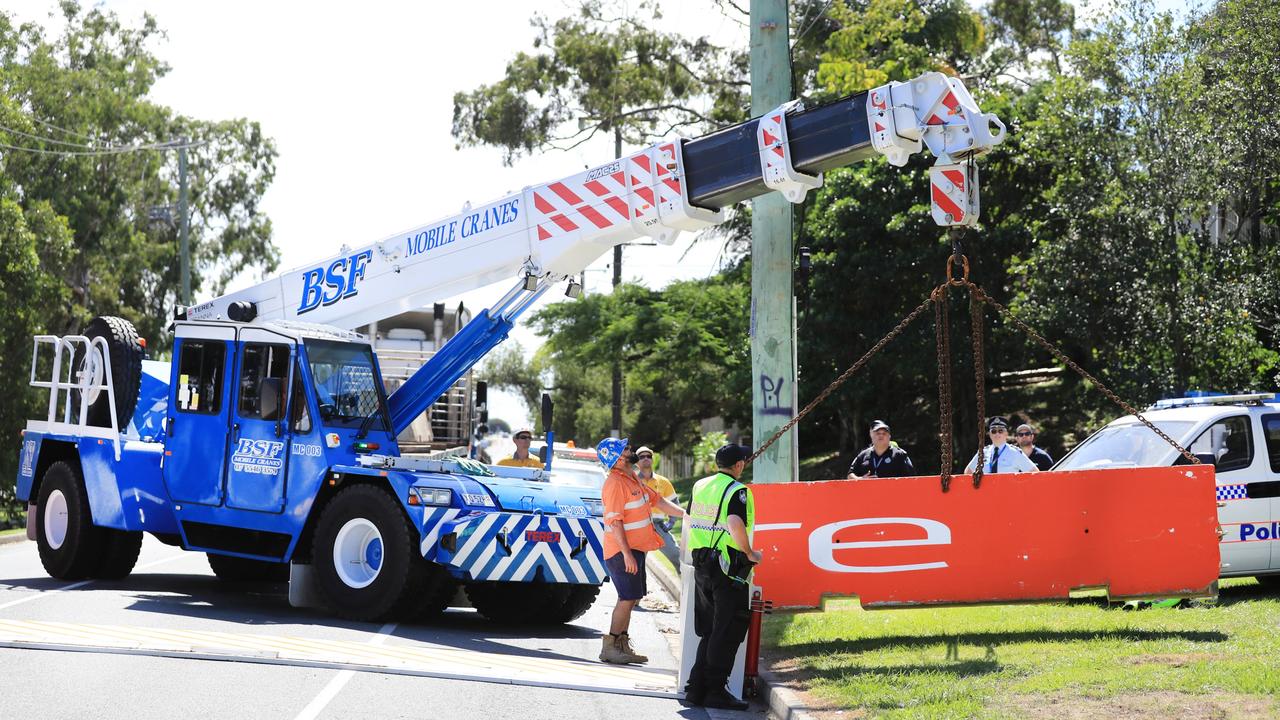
[225,328,297,512]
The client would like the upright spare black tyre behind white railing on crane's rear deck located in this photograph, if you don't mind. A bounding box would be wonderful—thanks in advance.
[72,316,146,430]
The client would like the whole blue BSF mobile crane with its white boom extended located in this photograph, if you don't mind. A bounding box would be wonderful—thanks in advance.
[18,73,1005,623]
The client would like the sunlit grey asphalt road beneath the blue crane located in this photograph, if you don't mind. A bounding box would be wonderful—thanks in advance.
[0,538,764,720]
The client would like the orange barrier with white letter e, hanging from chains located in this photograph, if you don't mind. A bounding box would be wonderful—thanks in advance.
[753,465,1219,607]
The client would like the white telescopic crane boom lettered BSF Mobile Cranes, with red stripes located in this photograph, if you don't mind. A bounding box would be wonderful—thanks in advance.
[179,73,1004,328]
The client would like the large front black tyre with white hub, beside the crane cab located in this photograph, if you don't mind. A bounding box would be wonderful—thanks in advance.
[312,486,428,621]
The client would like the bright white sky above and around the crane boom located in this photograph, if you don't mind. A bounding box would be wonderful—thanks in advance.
[5,0,746,424]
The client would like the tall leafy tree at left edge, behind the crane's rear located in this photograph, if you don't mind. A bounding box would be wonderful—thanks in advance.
[0,0,279,515]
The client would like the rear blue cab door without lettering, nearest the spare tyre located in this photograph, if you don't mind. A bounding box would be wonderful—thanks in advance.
[163,324,236,505]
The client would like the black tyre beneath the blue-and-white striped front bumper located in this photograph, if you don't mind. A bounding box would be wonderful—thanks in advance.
[466,583,600,625]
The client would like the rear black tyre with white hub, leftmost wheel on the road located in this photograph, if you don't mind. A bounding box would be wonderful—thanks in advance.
[36,461,104,580]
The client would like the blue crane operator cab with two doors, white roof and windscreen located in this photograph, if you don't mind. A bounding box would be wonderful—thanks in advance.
[164,322,396,514]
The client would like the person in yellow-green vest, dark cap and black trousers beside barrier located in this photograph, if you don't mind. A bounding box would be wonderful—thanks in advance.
[685,445,762,710]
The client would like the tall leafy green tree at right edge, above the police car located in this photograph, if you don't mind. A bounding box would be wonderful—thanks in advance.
[1016,3,1280,415]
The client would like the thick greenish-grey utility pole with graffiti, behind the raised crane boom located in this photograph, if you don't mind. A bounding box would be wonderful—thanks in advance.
[751,0,799,483]
